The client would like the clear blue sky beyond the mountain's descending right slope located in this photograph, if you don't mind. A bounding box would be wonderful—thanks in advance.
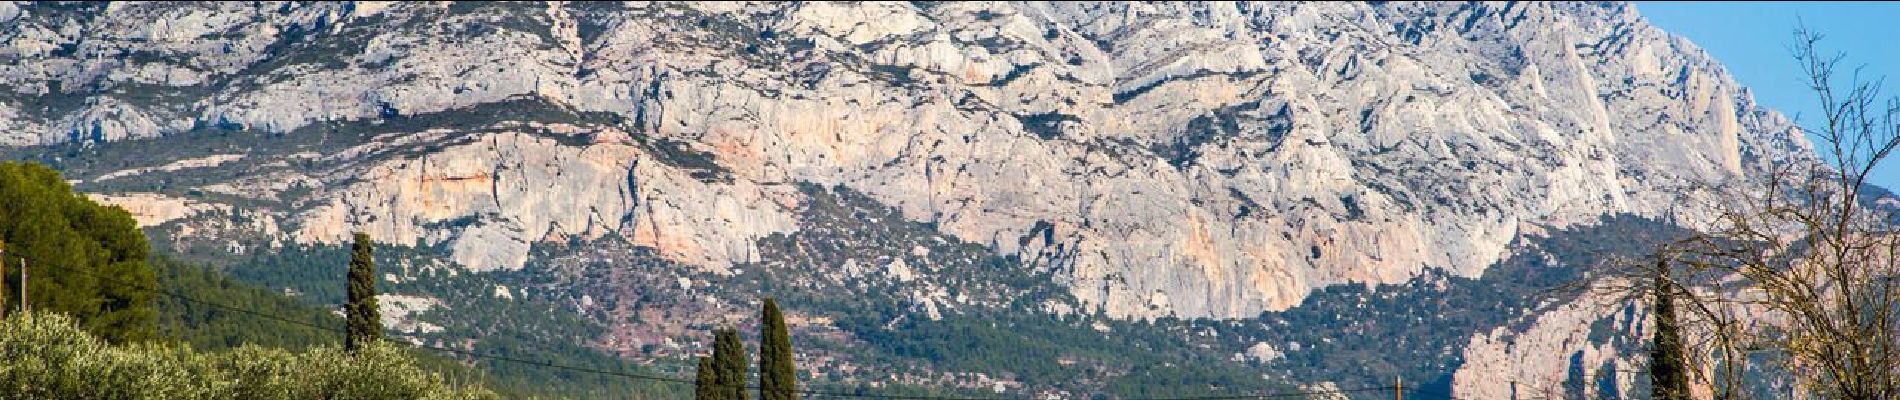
[1636,2,1900,190]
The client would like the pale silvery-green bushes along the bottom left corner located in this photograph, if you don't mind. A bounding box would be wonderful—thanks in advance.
[0,313,494,400]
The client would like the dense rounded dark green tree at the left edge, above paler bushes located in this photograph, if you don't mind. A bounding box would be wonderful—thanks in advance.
[0,163,156,341]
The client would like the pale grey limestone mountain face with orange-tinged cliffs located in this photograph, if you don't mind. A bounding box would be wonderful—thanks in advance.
[0,2,1811,318]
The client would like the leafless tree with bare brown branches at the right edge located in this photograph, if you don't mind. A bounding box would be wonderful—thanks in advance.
[1623,28,1900,398]
